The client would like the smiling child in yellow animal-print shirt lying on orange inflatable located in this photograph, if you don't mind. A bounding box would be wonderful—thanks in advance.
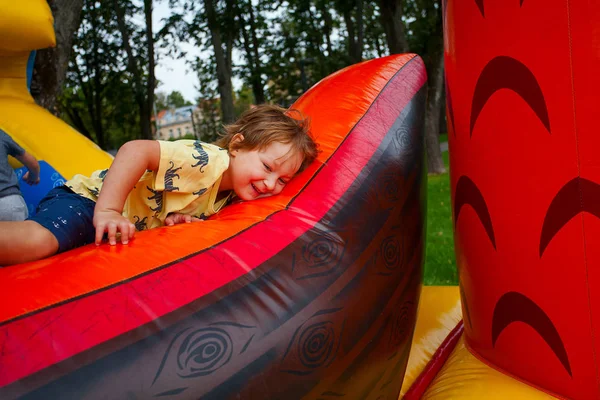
[0,105,318,265]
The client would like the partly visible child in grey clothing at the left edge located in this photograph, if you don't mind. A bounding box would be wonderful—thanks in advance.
[0,129,40,221]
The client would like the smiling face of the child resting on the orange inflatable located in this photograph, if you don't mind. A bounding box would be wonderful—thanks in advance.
[228,142,302,200]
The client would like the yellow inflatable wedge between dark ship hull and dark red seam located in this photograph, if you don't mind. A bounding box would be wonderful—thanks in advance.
[400,286,462,397]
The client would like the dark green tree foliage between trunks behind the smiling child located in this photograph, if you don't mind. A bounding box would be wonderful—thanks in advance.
[55,0,441,152]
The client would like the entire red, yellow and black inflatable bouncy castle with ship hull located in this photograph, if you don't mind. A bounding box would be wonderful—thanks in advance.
[8,0,600,400]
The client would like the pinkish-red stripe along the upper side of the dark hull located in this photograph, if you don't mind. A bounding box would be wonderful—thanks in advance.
[0,58,426,386]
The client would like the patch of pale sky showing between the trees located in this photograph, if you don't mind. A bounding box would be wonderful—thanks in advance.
[152,1,200,102]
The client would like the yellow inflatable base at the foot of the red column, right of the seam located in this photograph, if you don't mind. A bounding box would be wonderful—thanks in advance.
[422,337,556,400]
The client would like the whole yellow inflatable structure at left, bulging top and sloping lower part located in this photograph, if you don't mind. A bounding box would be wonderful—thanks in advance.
[0,0,112,179]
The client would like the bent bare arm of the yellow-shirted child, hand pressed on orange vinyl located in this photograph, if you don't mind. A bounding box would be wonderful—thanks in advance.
[94,140,160,245]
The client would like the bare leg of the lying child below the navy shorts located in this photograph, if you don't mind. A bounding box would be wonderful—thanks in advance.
[0,221,58,266]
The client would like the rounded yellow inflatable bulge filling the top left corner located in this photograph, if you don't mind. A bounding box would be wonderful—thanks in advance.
[0,0,56,54]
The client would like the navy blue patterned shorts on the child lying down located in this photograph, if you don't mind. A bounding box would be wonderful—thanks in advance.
[29,186,96,253]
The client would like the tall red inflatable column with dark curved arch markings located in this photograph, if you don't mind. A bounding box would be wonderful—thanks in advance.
[444,0,600,399]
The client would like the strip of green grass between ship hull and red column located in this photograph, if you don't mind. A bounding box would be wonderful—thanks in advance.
[424,139,458,285]
